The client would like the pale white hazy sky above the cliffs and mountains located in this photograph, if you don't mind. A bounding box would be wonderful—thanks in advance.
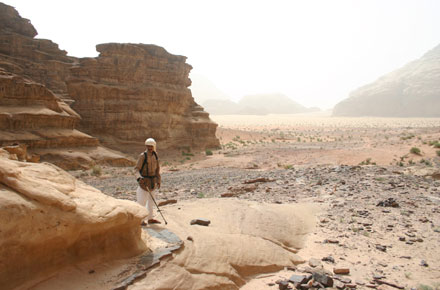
[0,0,440,109]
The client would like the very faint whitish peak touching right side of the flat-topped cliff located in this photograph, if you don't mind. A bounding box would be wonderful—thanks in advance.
[190,73,230,104]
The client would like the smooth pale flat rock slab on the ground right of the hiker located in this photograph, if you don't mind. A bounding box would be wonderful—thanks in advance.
[130,199,315,289]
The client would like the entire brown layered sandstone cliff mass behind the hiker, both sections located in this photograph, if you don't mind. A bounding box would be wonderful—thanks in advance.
[0,3,219,165]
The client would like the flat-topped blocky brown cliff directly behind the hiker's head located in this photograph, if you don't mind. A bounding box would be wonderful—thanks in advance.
[68,43,219,150]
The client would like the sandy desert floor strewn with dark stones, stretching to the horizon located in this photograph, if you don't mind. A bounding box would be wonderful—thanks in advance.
[62,115,440,290]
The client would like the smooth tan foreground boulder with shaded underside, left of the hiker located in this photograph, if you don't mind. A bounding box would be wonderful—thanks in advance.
[0,149,146,289]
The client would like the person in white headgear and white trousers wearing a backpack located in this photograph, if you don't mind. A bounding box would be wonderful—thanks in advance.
[135,138,161,225]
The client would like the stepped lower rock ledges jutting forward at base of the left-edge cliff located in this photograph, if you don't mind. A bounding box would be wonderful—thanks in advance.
[0,69,133,169]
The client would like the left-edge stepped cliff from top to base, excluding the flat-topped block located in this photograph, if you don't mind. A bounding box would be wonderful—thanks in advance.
[0,3,133,169]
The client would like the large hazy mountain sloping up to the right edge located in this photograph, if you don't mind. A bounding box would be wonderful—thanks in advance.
[333,45,440,117]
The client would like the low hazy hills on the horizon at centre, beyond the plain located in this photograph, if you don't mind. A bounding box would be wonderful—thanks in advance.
[202,94,319,115]
